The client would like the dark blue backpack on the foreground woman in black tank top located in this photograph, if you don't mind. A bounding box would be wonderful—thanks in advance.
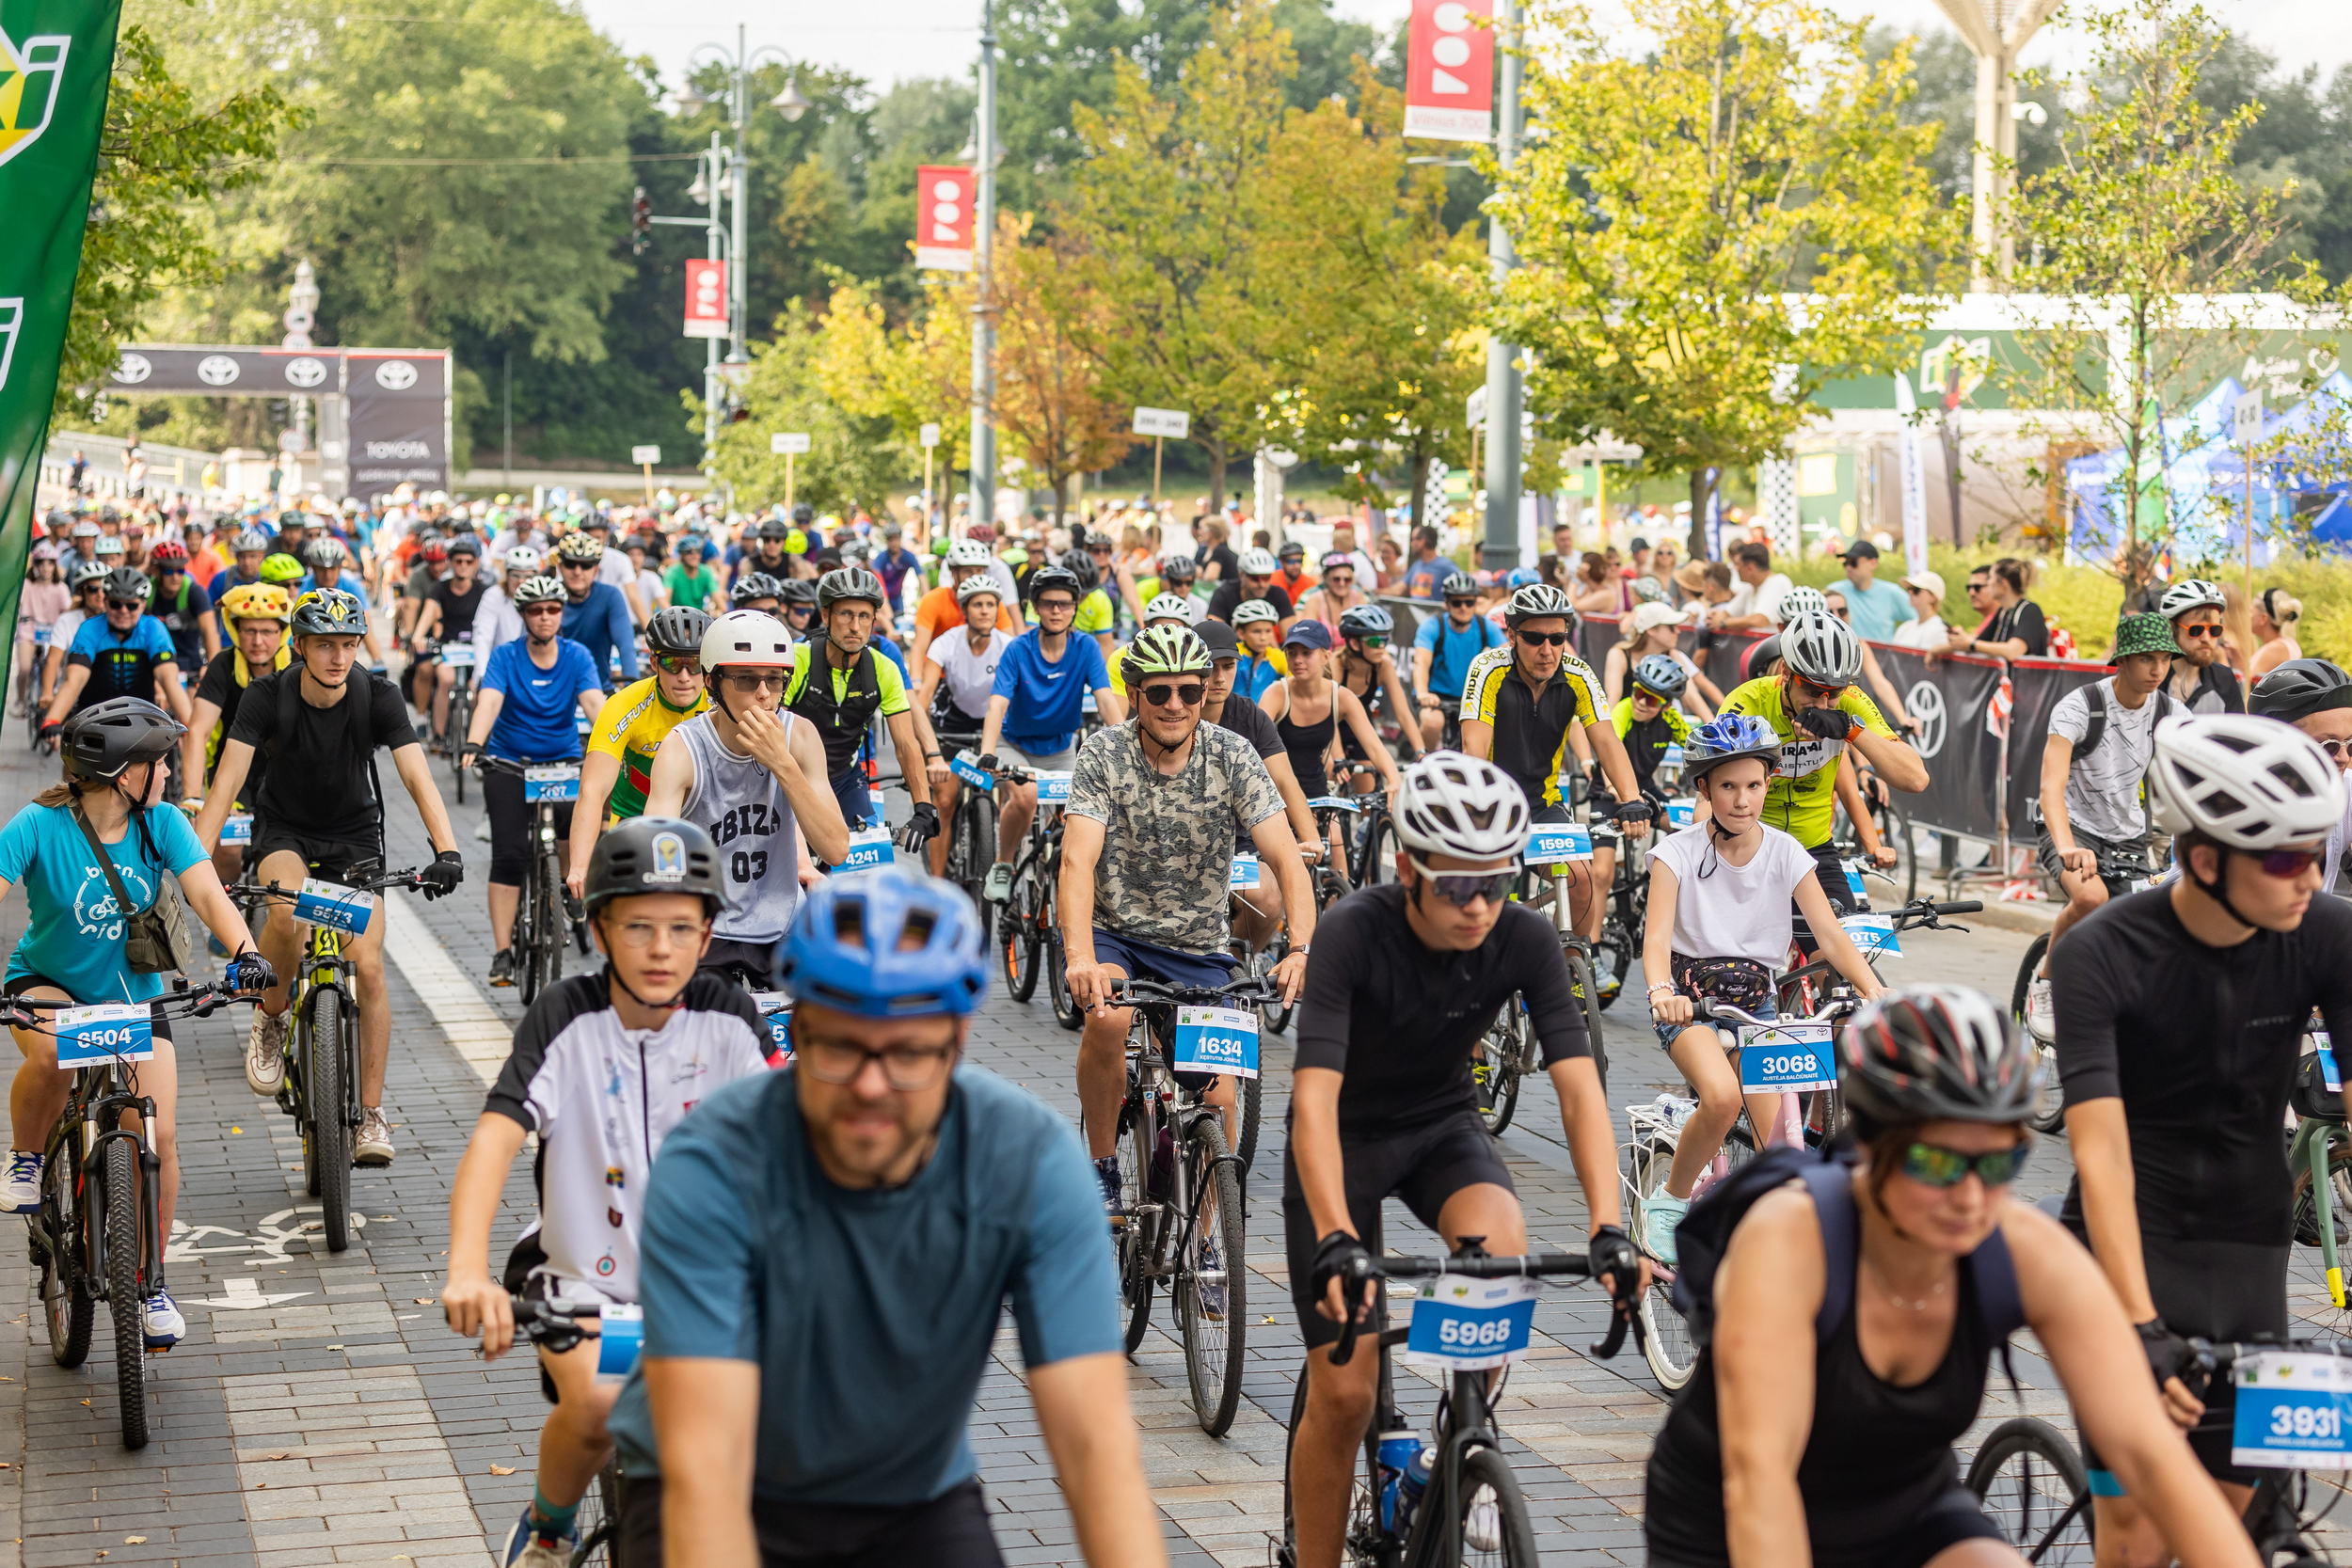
[1675,1145,2026,1361]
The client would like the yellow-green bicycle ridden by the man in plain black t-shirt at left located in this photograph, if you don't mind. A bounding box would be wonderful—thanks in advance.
[229,863,426,1253]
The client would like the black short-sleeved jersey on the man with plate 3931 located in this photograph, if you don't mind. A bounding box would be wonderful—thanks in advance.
[2051,888,2352,1241]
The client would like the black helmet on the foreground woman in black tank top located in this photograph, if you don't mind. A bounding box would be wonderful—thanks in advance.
[1837,985,2042,1140]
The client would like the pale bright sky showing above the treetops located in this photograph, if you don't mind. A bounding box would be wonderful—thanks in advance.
[581,0,2352,87]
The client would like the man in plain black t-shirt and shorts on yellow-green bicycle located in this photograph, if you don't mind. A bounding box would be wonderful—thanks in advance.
[196,593,466,1166]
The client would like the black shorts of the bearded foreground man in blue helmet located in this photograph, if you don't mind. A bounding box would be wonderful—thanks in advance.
[614,1465,1005,1568]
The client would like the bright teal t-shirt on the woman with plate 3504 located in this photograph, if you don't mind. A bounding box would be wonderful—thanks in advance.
[0,804,205,1002]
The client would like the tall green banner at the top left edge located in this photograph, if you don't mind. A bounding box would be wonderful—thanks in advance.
[0,0,122,719]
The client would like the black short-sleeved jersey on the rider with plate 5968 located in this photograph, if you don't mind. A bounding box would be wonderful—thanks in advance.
[1294,884,1593,1143]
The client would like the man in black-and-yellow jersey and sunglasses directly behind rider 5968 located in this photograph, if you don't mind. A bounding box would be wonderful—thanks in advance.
[1461,583,1656,941]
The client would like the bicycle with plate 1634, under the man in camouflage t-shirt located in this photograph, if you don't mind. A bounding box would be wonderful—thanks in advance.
[1110,980,1270,1436]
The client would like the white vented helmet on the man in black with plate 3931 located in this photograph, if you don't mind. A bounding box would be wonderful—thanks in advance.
[2148,712,2345,851]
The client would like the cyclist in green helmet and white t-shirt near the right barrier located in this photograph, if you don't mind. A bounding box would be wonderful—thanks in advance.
[2026,613,2181,1044]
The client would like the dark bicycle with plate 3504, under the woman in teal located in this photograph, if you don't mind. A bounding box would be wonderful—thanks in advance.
[0,985,252,1449]
